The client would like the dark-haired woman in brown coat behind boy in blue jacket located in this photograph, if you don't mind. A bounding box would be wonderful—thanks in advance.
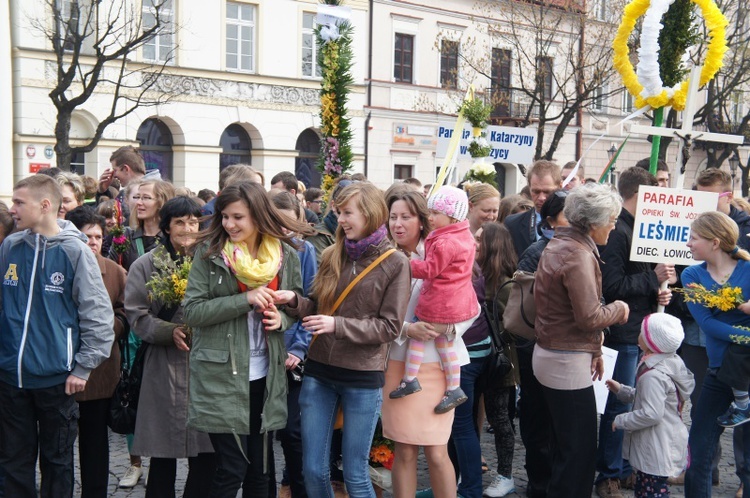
[65,207,128,498]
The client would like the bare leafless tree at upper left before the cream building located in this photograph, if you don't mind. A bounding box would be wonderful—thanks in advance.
[31,0,184,170]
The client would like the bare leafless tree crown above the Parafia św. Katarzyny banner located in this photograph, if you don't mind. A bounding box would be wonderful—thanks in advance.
[452,0,621,159]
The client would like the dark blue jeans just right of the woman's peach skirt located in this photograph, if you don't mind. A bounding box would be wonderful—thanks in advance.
[451,356,487,498]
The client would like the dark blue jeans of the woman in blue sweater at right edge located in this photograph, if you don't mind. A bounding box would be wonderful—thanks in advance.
[685,369,750,498]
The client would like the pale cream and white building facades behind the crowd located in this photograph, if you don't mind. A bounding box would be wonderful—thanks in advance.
[0,0,744,198]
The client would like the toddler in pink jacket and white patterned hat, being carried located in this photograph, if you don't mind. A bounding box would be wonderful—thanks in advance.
[389,186,479,413]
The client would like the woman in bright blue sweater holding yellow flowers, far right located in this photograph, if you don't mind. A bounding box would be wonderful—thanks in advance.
[681,211,750,498]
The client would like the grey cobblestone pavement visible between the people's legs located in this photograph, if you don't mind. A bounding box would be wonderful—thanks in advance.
[75,406,739,498]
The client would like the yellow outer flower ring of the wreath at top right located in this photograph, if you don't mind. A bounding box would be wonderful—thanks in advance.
[612,0,728,111]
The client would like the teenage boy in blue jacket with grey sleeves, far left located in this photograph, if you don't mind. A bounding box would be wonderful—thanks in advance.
[0,175,113,498]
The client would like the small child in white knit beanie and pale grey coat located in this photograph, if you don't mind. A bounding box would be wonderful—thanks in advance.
[606,313,695,498]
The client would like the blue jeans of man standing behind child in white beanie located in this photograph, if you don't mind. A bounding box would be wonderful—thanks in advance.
[596,342,640,482]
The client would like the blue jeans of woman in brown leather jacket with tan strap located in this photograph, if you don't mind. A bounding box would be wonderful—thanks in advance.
[299,376,383,498]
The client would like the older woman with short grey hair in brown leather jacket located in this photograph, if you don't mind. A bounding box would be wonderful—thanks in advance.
[532,185,629,498]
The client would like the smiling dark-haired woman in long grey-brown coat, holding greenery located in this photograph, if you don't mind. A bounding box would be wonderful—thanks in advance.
[125,196,215,498]
